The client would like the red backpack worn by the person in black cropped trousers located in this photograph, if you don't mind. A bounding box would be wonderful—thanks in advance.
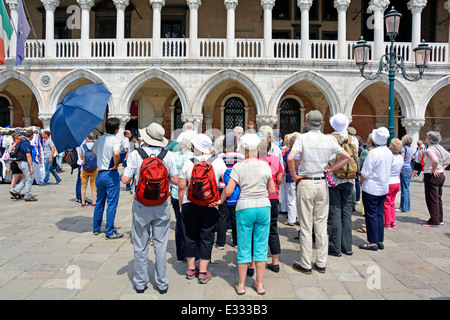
[187,157,220,207]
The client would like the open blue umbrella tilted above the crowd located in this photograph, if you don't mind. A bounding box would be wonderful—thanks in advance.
[50,83,111,152]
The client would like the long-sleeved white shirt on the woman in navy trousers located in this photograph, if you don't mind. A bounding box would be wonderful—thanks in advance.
[361,146,394,196]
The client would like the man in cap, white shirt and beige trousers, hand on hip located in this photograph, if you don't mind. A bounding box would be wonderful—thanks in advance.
[287,110,350,274]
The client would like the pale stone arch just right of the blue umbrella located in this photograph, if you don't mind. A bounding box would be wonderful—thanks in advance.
[119,69,190,113]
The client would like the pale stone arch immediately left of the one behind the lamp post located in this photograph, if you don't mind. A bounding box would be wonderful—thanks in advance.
[269,70,341,115]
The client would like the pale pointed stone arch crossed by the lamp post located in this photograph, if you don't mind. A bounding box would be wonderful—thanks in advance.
[344,75,416,118]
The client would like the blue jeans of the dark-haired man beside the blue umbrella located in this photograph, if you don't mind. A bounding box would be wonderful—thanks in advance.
[93,170,120,236]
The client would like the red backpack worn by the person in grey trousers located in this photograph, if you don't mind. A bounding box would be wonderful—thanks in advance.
[134,148,170,207]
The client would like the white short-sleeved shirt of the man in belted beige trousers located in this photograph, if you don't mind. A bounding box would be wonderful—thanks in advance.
[292,130,344,177]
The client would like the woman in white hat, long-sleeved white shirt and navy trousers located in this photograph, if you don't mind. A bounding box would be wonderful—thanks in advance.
[359,127,394,251]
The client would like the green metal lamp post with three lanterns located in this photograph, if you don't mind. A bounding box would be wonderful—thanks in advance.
[353,7,431,142]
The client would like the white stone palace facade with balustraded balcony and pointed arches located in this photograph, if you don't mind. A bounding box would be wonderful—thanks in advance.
[0,0,450,150]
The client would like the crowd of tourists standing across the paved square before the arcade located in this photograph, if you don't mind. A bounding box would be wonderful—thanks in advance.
[1,110,450,295]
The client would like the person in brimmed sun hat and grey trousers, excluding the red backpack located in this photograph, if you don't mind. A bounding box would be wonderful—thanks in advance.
[122,123,178,294]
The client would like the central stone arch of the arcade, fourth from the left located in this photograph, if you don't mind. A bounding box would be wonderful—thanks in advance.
[192,69,266,114]
